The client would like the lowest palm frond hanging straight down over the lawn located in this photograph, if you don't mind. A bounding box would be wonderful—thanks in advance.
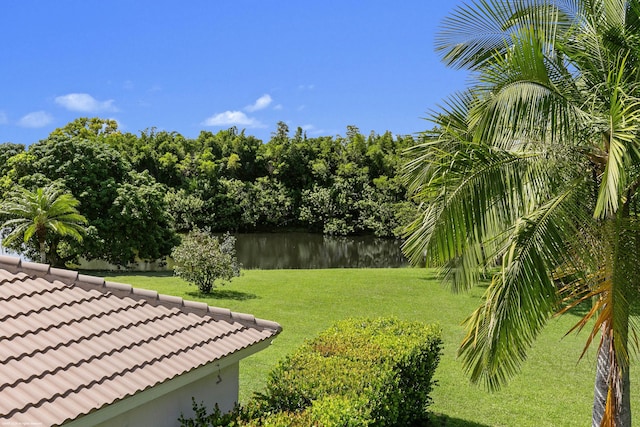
[459,187,583,390]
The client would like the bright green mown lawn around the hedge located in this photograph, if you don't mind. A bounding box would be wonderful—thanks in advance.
[105,268,640,427]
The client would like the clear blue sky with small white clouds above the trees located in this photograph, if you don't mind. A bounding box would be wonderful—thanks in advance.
[0,0,466,145]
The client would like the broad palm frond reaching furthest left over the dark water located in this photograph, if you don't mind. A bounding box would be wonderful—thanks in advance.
[403,132,553,296]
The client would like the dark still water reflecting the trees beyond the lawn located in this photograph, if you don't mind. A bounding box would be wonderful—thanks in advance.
[236,233,408,269]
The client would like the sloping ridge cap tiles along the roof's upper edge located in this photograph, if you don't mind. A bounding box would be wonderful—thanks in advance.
[0,255,282,332]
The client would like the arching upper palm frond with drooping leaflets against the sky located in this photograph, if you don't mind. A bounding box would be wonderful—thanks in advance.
[470,24,579,146]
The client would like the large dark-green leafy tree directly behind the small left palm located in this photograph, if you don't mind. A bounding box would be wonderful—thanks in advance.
[7,134,176,265]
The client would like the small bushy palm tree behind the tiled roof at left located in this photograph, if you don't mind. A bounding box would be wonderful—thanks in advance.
[0,185,87,263]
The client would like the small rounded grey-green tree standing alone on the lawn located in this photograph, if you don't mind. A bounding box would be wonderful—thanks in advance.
[171,230,240,294]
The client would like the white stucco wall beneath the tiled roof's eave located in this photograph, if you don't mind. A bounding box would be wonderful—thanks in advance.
[91,363,239,427]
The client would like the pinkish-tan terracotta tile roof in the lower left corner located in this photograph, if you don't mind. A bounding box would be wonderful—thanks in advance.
[0,256,281,425]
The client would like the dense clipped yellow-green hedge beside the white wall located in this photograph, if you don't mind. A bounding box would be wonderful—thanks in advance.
[178,318,442,427]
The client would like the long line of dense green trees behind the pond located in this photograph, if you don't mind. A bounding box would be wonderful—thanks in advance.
[0,118,417,265]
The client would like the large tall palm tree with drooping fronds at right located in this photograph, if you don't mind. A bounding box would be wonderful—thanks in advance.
[404,0,640,426]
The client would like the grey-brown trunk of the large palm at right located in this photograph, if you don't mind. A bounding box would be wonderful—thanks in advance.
[591,325,631,427]
